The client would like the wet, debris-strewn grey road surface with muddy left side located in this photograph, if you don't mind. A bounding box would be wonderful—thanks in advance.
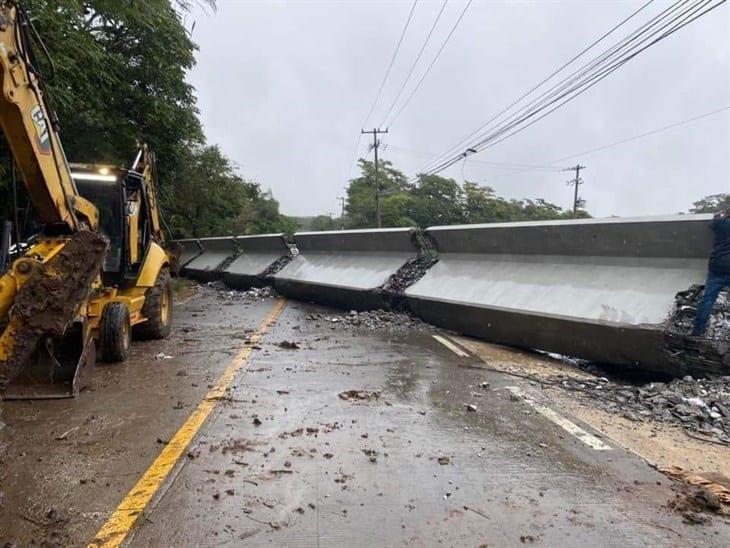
[0,289,730,547]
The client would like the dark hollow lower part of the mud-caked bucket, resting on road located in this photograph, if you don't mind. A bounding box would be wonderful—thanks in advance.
[3,323,96,400]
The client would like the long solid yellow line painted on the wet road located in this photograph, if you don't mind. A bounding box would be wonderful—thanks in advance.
[89,299,286,548]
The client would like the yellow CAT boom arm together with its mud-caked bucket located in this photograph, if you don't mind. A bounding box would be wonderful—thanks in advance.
[0,0,107,394]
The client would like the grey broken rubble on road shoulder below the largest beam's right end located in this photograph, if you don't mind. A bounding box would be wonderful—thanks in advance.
[557,376,730,444]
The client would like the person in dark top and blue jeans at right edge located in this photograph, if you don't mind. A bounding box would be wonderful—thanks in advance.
[692,209,730,336]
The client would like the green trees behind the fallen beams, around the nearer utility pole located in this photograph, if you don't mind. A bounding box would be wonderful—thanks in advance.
[345,159,589,228]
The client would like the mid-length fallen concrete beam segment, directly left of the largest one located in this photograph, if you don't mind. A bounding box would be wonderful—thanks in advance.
[274,228,418,310]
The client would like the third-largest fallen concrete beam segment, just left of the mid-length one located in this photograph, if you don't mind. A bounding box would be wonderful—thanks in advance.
[223,234,292,289]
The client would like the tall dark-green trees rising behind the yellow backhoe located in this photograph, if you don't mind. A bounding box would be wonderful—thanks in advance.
[0,0,296,236]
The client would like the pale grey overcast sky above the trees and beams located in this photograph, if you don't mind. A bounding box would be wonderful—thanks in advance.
[186,0,730,216]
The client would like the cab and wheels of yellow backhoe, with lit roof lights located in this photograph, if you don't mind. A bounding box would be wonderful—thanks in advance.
[71,147,174,362]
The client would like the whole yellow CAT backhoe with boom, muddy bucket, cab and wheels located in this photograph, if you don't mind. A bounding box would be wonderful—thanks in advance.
[0,0,174,399]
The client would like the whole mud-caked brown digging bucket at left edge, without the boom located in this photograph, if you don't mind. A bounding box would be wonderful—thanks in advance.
[0,230,108,399]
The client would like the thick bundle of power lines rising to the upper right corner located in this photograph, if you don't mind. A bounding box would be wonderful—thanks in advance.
[416,0,726,178]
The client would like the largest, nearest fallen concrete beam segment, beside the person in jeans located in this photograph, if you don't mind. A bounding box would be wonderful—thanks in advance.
[406,215,712,374]
